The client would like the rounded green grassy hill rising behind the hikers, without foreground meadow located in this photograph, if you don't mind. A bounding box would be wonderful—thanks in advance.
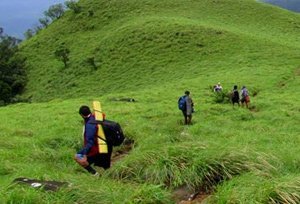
[22,0,300,101]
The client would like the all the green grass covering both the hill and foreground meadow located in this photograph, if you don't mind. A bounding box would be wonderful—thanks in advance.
[0,0,300,203]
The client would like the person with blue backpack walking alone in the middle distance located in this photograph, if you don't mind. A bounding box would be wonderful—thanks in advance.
[178,91,194,125]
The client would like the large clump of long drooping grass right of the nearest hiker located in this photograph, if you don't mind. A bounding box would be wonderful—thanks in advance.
[108,143,274,191]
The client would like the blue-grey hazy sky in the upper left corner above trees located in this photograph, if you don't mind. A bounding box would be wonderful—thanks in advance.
[0,0,64,38]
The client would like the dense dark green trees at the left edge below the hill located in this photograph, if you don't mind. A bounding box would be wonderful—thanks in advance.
[0,29,26,105]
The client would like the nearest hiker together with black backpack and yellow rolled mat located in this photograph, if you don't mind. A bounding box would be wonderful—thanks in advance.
[74,103,124,176]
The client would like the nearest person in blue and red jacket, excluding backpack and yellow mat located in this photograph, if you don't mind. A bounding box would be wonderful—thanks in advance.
[74,106,112,176]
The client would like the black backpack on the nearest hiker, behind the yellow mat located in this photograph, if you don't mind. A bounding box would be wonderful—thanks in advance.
[96,120,125,146]
